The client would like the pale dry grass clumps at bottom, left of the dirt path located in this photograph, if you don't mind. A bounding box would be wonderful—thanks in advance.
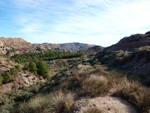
[13,91,74,113]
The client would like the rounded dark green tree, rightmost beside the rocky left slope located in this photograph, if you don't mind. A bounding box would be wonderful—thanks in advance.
[37,61,49,78]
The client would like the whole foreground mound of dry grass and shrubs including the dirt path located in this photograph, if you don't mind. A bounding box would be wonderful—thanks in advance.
[2,59,150,113]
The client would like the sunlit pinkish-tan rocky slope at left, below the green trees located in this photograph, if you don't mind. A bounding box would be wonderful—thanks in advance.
[0,56,43,93]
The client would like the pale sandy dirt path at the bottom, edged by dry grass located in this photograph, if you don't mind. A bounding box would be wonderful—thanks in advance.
[74,96,138,113]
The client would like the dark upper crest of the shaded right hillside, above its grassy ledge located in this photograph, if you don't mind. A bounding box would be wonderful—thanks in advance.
[110,31,150,50]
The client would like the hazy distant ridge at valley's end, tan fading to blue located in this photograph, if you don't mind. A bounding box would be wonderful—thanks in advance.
[34,42,94,51]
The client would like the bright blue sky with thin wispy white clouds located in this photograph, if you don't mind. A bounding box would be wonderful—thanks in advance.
[0,0,150,47]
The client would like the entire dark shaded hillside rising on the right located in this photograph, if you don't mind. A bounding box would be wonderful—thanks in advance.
[94,32,150,85]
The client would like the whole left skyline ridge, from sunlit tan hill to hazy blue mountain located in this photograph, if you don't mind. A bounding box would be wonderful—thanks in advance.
[0,37,94,56]
